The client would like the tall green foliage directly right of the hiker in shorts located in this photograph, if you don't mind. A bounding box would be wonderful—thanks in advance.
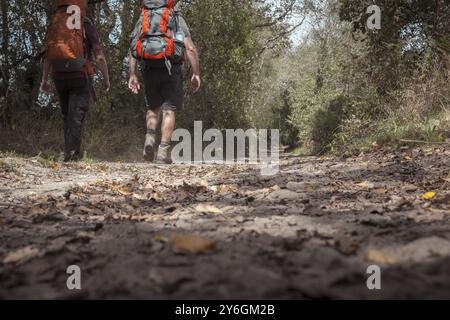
[180,0,261,128]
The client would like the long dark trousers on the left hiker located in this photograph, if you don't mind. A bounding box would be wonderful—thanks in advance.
[55,78,91,161]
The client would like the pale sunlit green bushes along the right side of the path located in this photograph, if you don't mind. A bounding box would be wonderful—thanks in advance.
[272,0,450,153]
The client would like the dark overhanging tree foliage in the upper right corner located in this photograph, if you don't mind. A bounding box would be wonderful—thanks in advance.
[338,0,450,94]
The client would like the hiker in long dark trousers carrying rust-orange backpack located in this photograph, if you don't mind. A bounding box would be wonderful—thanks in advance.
[41,0,110,162]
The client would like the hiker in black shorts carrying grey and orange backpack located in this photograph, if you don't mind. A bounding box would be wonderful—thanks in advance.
[128,0,201,164]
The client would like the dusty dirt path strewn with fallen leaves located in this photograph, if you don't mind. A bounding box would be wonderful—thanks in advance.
[0,149,450,299]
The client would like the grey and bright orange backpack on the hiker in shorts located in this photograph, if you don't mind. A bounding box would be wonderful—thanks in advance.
[131,0,181,73]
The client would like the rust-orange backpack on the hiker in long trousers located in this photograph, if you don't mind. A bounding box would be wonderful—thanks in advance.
[45,0,87,73]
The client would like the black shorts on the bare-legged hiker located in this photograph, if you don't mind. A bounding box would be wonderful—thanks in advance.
[143,64,184,111]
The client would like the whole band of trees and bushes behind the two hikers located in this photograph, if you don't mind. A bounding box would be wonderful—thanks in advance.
[0,0,450,160]
